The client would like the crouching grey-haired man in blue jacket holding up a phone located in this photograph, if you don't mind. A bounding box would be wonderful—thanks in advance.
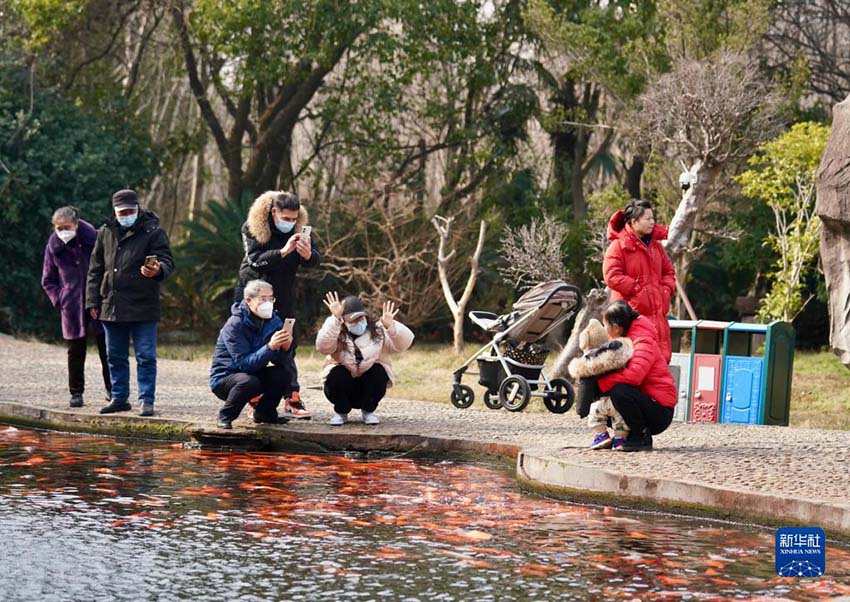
[210,280,292,429]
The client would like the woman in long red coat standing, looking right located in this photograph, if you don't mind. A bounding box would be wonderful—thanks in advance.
[602,200,676,363]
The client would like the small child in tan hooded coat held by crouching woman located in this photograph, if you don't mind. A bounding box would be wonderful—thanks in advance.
[569,319,633,450]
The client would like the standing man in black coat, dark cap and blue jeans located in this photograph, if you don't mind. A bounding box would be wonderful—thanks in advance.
[86,190,174,416]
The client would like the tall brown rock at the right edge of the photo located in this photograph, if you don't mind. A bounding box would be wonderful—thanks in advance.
[815,96,850,367]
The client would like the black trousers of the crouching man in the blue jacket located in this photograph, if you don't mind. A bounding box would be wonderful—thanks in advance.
[213,366,292,422]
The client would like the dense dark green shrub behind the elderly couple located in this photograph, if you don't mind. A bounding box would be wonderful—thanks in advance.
[0,55,157,336]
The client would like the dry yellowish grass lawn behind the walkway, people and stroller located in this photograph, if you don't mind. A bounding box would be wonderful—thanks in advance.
[159,344,850,430]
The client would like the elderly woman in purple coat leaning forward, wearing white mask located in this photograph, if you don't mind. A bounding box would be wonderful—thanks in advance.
[41,207,112,408]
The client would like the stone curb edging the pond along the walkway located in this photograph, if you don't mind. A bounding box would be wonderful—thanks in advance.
[0,401,850,542]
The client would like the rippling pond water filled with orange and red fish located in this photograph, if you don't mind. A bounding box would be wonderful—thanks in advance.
[0,426,850,602]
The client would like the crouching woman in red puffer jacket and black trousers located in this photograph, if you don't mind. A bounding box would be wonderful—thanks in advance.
[598,301,677,451]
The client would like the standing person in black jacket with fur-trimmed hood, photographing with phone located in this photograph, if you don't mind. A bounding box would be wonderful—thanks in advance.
[235,190,321,419]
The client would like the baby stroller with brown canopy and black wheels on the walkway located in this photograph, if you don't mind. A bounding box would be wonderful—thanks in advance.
[451,280,581,414]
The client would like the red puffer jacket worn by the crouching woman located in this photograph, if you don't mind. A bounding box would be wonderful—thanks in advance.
[598,316,678,408]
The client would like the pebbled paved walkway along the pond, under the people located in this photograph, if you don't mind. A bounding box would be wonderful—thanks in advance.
[0,335,850,538]
